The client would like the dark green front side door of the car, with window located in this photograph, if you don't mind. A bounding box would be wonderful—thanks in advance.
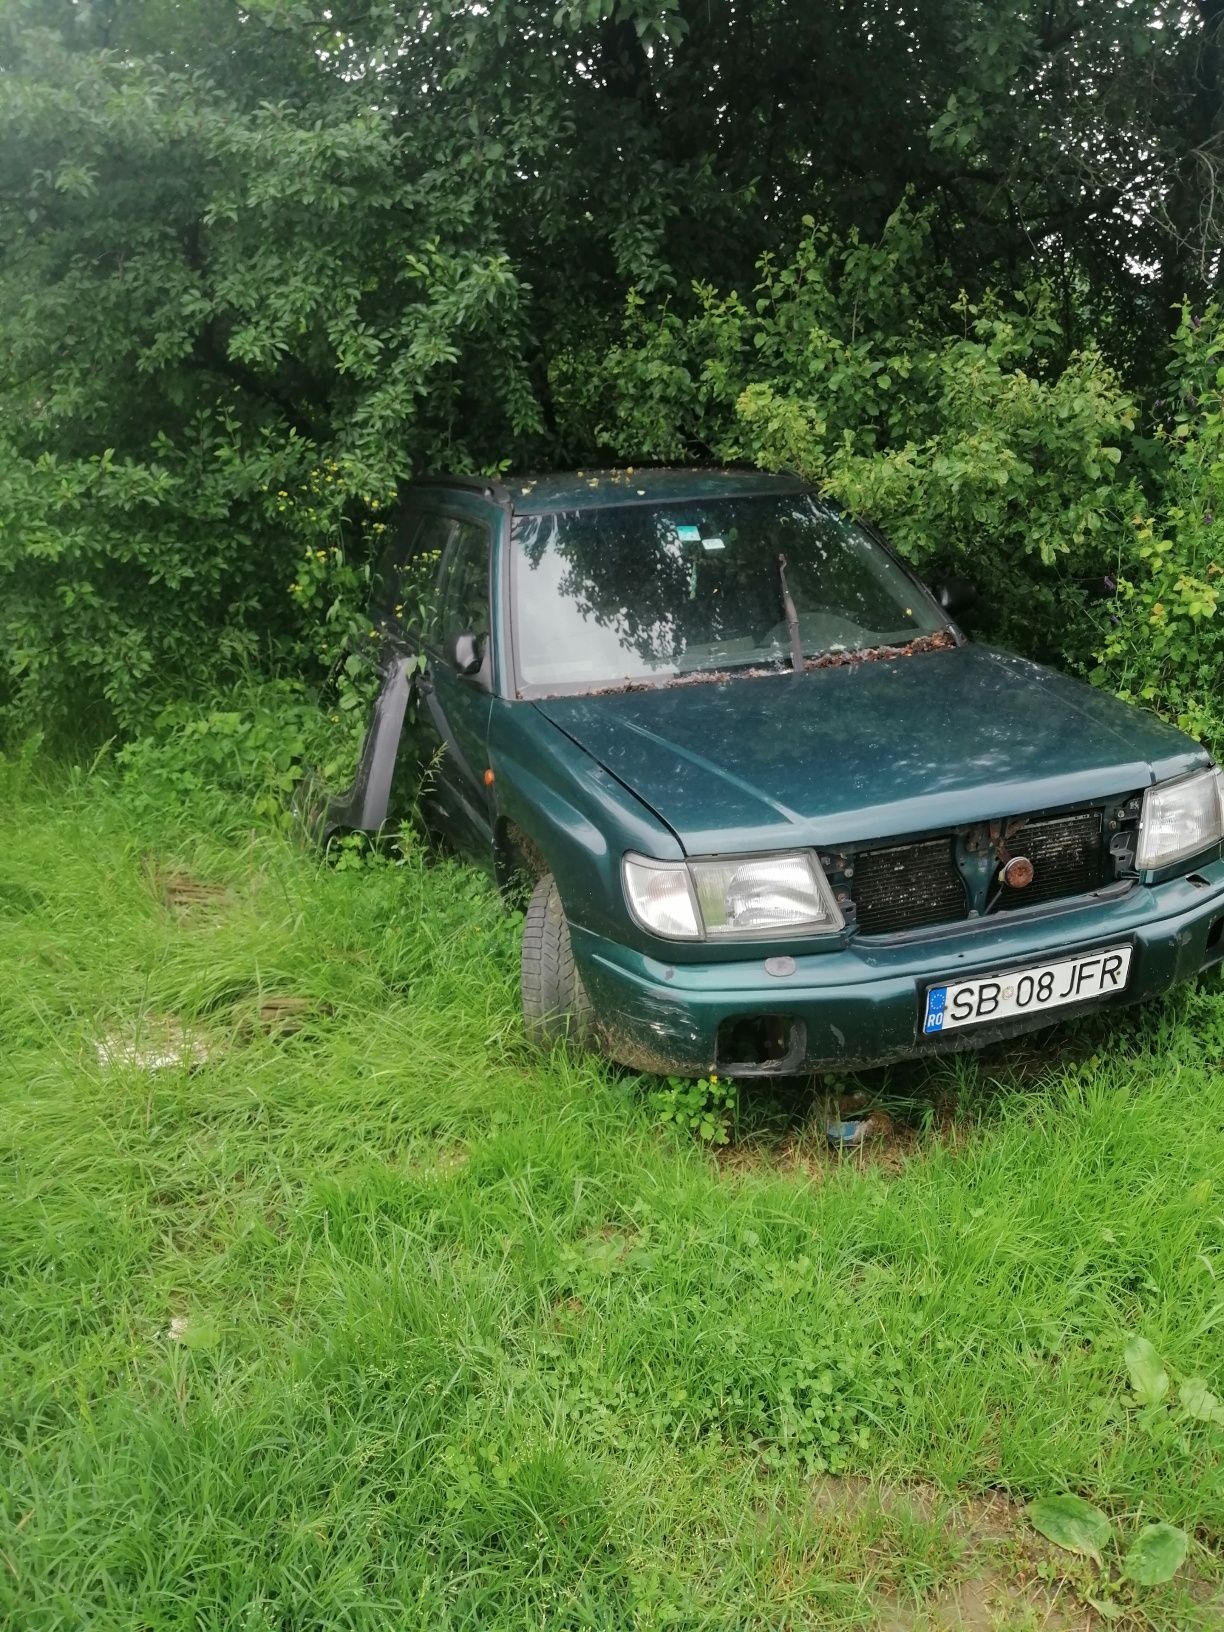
[416,512,493,860]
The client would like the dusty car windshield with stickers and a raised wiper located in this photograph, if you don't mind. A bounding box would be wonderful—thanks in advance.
[512,493,948,689]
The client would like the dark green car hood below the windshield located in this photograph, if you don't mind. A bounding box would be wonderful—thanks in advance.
[535,645,1208,855]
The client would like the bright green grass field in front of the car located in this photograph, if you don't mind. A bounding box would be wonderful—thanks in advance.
[0,765,1224,1632]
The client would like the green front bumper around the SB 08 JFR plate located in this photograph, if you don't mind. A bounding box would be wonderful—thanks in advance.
[573,858,1224,1075]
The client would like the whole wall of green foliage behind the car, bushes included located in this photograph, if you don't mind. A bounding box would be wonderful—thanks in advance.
[0,0,1224,726]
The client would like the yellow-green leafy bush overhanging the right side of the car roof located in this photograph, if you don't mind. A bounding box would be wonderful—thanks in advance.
[555,204,1136,661]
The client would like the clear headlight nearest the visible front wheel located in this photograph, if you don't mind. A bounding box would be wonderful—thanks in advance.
[623,850,844,940]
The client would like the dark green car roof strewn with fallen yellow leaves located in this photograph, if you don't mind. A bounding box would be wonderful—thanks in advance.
[428,465,806,516]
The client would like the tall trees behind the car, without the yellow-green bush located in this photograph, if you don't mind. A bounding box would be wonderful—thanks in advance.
[0,0,1224,723]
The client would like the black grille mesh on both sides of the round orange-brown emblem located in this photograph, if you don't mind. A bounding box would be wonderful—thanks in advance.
[845,809,1110,935]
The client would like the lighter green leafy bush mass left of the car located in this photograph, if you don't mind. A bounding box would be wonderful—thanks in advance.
[0,20,537,736]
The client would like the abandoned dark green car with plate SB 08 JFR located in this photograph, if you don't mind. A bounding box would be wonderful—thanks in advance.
[317,470,1224,1075]
